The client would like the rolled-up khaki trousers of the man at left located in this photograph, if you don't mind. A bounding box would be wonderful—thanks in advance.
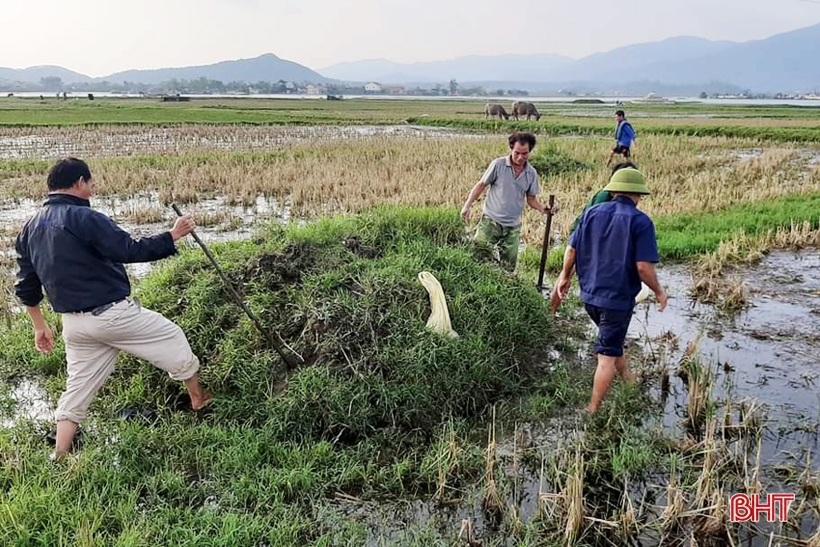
[56,300,199,423]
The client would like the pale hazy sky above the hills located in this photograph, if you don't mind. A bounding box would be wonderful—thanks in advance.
[0,0,820,76]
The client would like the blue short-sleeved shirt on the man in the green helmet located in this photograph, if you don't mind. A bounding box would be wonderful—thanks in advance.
[569,196,658,310]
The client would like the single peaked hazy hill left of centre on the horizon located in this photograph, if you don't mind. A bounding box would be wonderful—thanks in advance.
[98,53,329,84]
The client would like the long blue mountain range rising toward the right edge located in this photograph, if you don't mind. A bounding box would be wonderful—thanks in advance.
[319,25,820,92]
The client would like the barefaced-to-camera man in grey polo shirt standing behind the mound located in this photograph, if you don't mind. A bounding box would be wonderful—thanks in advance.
[461,132,557,271]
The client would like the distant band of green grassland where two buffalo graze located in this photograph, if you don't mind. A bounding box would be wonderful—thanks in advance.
[0,98,820,147]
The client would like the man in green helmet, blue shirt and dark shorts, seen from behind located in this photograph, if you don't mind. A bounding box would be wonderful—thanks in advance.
[558,169,667,413]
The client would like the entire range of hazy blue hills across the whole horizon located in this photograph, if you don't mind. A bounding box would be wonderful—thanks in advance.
[0,24,820,94]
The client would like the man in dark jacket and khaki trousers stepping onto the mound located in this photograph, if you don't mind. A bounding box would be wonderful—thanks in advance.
[15,158,213,458]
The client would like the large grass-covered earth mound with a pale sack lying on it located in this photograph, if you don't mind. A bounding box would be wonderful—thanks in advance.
[135,209,550,442]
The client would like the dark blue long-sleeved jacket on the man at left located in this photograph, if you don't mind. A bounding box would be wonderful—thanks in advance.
[14,194,176,313]
